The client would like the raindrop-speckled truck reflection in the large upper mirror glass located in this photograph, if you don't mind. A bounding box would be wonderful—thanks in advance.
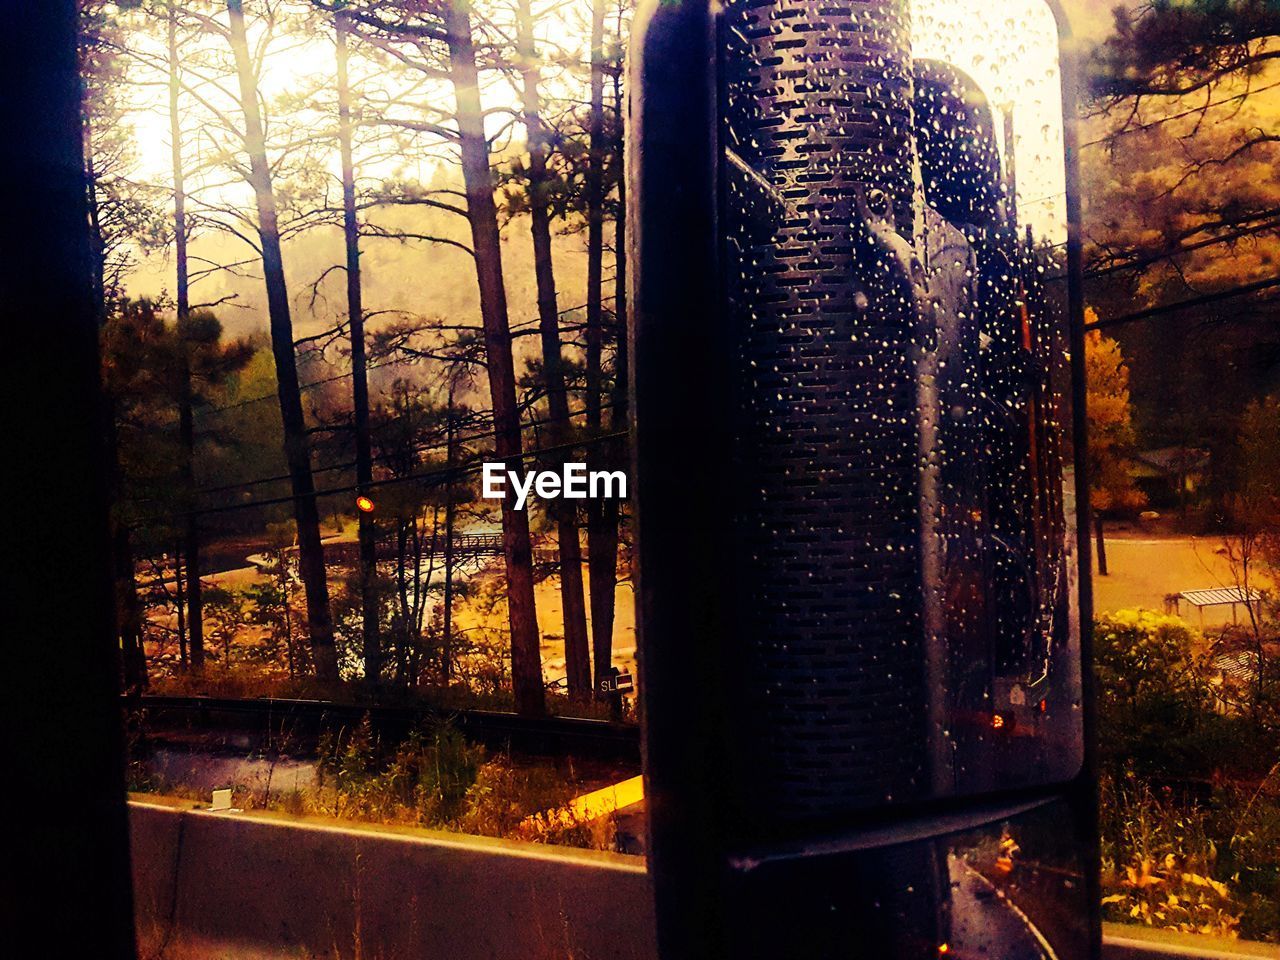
[722,0,1082,832]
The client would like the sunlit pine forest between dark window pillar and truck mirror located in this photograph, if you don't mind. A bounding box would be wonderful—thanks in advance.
[82,0,630,716]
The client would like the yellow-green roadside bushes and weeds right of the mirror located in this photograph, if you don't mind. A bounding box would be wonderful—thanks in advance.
[1094,611,1280,942]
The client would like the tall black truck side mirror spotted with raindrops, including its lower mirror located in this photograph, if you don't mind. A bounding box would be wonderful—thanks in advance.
[627,0,1097,957]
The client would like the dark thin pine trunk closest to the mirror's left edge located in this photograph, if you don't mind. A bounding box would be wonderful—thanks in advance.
[590,45,628,696]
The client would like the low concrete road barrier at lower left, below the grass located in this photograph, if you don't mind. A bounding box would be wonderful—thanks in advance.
[129,801,657,960]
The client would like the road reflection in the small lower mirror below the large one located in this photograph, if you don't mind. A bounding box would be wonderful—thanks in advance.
[742,803,1089,960]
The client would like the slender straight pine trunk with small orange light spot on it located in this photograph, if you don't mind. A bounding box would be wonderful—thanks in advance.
[334,12,381,684]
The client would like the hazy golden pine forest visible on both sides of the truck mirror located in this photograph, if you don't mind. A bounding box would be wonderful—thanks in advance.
[82,0,1280,696]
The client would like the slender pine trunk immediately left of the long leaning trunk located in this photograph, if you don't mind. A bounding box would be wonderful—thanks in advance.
[169,6,205,673]
